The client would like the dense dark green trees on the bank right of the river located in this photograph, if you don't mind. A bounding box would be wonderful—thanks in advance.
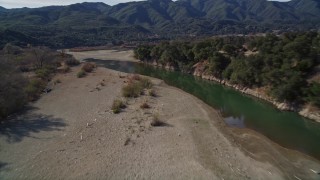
[134,32,320,107]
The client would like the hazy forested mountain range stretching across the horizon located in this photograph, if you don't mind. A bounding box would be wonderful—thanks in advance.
[0,0,320,47]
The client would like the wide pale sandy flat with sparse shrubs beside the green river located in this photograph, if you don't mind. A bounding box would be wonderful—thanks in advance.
[0,51,320,179]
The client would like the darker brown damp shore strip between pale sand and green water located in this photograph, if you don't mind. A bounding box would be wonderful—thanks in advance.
[57,48,319,177]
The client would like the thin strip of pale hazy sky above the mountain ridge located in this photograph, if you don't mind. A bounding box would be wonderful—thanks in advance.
[0,0,288,8]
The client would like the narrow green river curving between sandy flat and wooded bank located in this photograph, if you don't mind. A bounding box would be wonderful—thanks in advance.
[88,59,320,160]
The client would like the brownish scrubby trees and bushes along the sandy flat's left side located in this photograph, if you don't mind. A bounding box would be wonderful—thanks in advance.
[0,44,79,120]
